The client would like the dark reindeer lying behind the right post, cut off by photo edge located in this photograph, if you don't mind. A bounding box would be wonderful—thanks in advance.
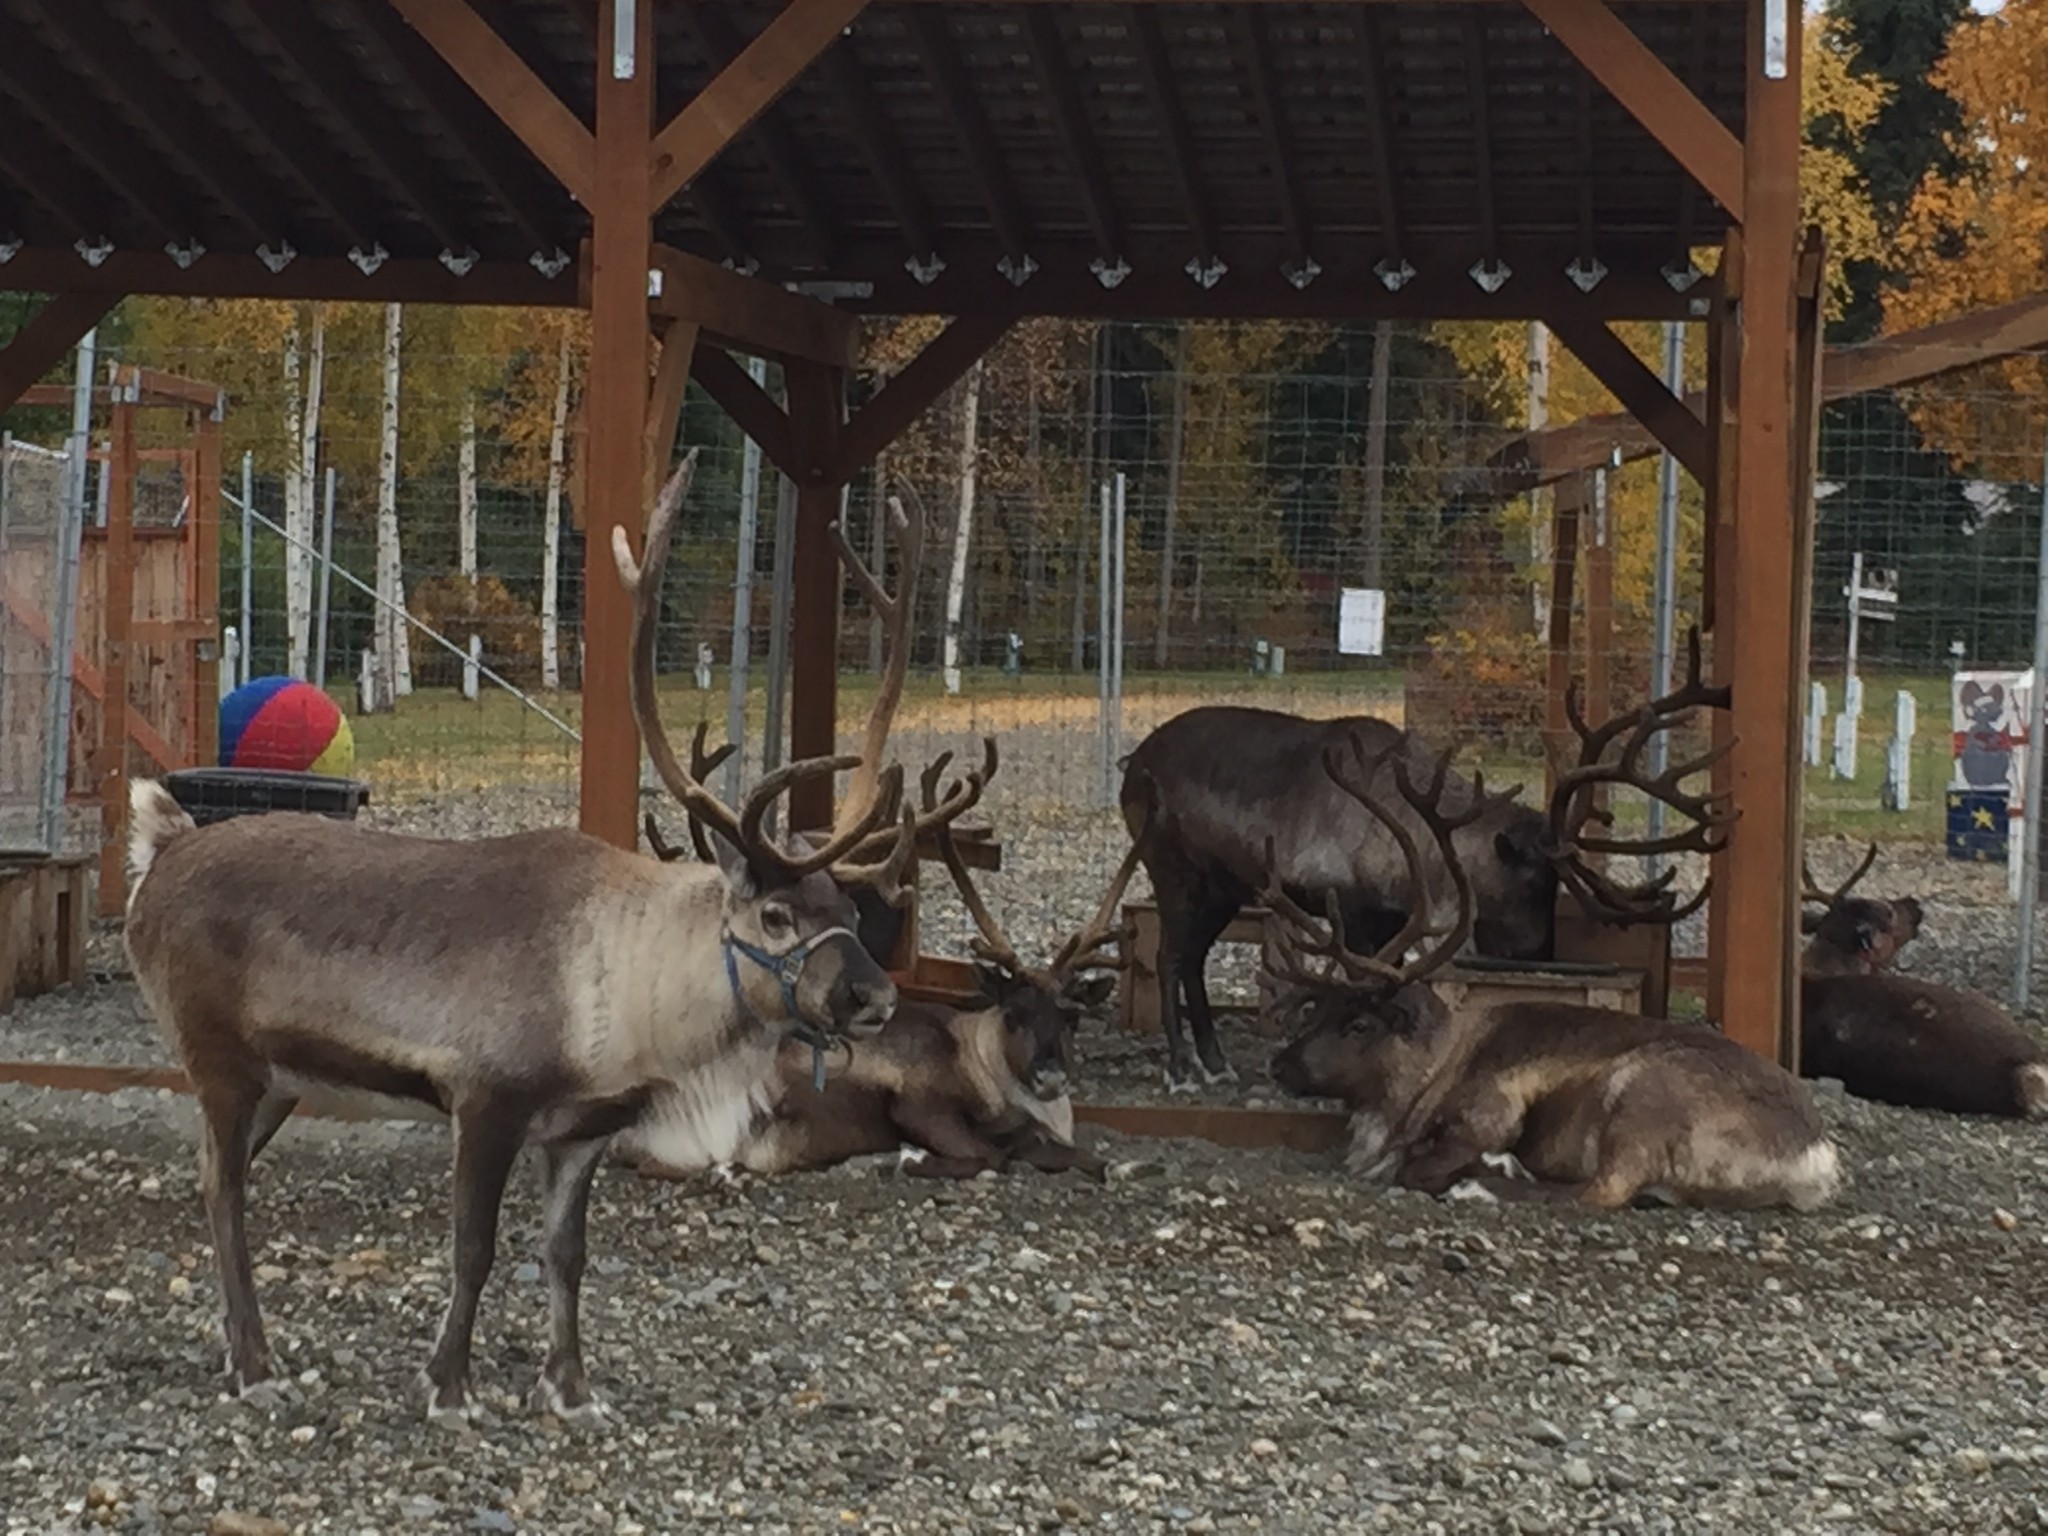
[1800,844,2048,1118]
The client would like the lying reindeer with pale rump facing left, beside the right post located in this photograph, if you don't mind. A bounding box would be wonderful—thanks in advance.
[1266,739,1841,1210]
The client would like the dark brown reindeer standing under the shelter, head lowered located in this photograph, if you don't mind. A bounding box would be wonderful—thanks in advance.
[1122,629,1726,1092]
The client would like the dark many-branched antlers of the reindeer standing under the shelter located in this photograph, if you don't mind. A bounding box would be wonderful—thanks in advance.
[1548,625,1737,924]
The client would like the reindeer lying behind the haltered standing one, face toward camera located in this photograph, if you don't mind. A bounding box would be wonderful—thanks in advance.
[621,753,1137,1178]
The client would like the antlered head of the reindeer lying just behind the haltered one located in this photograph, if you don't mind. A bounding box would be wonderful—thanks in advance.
[922,753,1139,1100]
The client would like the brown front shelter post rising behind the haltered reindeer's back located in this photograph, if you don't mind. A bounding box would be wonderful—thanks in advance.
[578,4,655,848]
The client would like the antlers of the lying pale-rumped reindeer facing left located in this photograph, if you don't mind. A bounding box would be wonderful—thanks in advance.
[1262,731,1520,993]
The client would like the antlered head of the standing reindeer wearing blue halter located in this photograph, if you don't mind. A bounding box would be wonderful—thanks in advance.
[612,449,913,1044]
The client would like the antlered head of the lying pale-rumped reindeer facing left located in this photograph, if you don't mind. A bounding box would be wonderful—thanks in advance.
[1264,735,1516,1178]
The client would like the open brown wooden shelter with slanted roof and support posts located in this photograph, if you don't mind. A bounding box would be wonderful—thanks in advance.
[0,0,1823,1055]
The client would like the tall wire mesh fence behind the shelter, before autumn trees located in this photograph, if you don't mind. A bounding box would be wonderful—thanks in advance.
[4,301,2042,962]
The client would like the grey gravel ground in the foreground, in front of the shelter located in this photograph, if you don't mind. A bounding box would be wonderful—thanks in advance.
[0,1087,2048,1536]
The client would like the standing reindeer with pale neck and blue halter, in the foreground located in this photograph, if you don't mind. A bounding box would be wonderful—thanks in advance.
[127,451,929,1421]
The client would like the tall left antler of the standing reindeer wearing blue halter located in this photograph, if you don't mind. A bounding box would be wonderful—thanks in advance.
[612,449,911,883]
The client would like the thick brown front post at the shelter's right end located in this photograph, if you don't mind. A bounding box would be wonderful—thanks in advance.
[1716,0,1800,1061]
